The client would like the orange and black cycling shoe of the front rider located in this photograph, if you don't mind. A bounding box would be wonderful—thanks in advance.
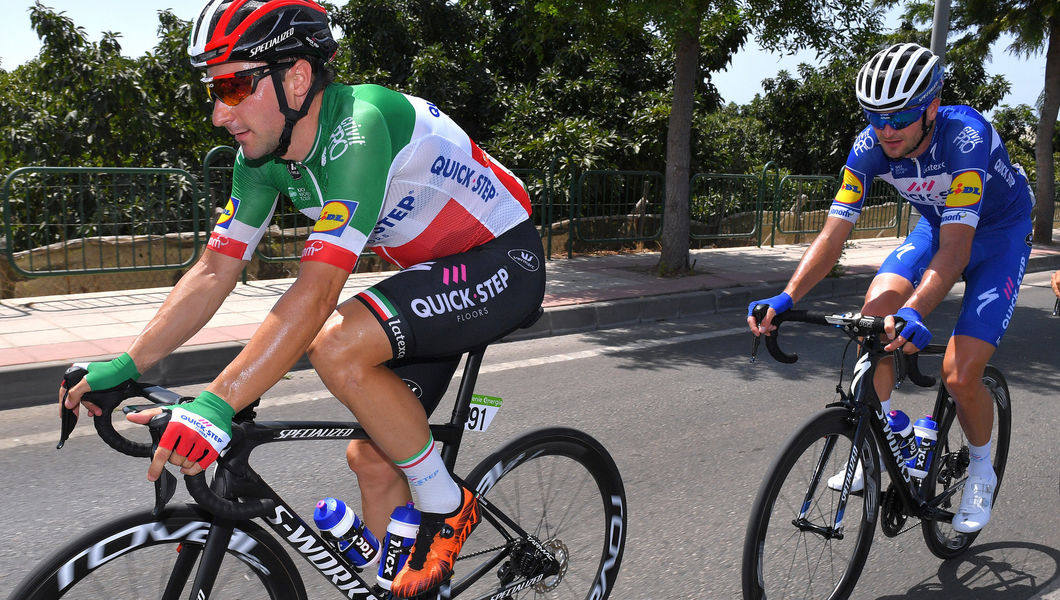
[390,488,479,598]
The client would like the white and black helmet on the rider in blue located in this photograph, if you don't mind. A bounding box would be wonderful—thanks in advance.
[854,43,942,112]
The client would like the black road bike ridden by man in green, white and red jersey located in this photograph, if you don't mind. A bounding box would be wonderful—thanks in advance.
[12,313,626,600]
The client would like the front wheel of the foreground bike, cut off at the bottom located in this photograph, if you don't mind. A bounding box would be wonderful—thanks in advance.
[11,506,306,600]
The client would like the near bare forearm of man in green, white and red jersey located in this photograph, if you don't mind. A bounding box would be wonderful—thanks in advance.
[207,263,348,410]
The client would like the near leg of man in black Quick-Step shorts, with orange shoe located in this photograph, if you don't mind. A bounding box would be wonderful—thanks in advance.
[311,222,545,596]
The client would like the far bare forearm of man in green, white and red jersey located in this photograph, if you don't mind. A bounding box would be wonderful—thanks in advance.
[128,252,242,373]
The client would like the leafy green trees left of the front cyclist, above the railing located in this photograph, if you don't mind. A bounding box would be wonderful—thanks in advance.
[0,2,223,171]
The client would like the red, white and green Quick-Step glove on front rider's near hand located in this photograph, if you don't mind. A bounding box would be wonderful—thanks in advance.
[158,391,235,469]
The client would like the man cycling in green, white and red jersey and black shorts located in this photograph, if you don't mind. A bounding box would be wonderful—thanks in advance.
[56,0,545,598]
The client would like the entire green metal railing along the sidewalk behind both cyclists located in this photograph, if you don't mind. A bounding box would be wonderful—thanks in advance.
[6,151,1060,294]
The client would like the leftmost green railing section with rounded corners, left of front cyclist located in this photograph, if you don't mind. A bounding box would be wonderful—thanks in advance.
[2,166,202,277]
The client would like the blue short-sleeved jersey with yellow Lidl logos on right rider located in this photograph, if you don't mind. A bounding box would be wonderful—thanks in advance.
[829,106,1034,231]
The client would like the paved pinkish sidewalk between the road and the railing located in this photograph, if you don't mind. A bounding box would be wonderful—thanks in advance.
[0,231,1060,409]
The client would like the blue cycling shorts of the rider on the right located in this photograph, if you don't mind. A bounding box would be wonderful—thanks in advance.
[877,218,1032,347]
